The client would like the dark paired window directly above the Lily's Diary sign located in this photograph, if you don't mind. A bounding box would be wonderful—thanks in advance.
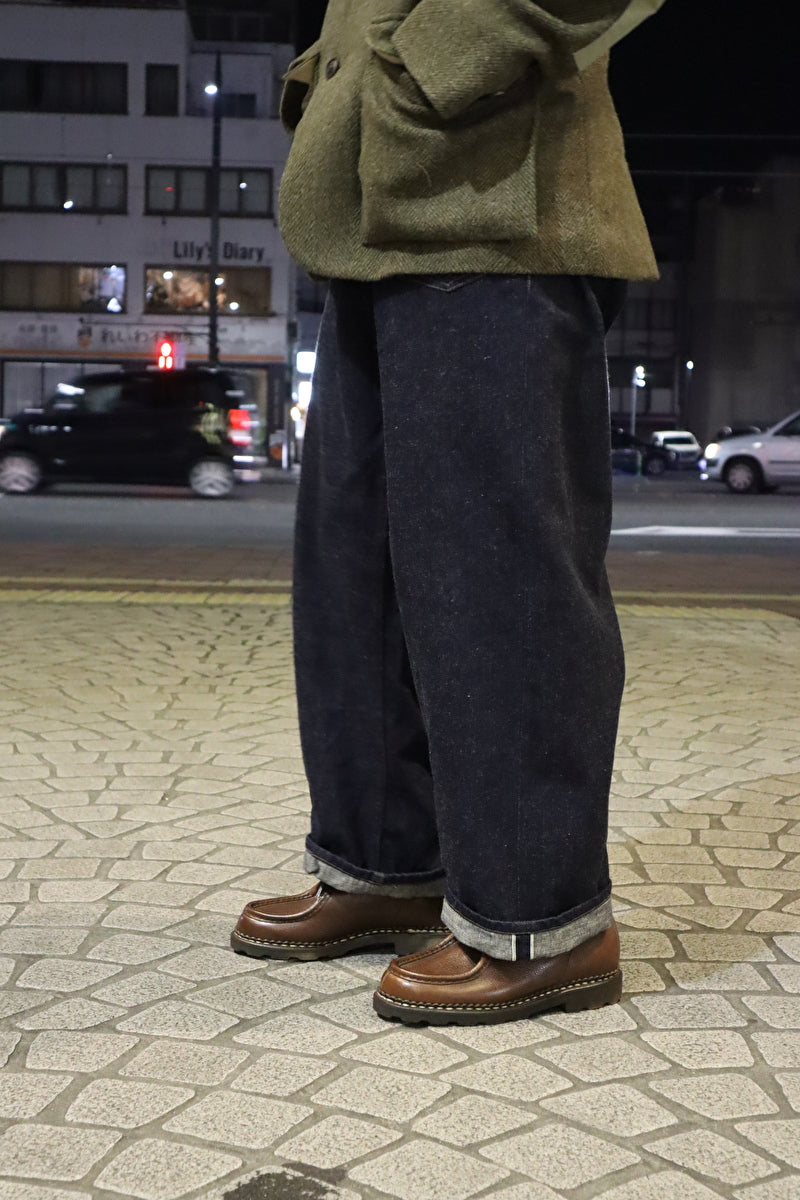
[145,167,272,217]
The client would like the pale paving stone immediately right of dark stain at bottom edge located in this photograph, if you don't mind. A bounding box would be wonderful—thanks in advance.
[349,1138,509,1200]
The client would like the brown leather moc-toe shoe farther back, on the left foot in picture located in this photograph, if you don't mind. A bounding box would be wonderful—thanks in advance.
[230,883,447,960]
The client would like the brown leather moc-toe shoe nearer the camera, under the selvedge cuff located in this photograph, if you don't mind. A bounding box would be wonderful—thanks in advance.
[373,925,622,1025]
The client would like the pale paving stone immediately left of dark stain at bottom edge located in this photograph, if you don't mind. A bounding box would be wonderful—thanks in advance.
[92,1130,241,1200]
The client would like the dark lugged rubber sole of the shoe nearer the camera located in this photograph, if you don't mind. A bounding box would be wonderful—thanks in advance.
[373,971,622,1025]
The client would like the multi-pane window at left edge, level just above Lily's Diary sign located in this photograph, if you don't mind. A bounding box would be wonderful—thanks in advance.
[0,162,127,212]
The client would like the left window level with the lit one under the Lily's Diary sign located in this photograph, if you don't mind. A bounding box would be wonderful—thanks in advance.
[0,263,126,313]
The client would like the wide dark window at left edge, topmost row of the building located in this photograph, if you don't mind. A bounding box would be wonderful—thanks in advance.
[0,59,128,114]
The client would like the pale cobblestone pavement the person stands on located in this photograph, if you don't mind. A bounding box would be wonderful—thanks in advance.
[0,592,800,1200]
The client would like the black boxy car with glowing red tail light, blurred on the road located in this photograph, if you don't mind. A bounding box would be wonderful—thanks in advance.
[0,367,259,499]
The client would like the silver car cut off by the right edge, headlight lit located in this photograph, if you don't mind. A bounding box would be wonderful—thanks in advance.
[699,412,800,496]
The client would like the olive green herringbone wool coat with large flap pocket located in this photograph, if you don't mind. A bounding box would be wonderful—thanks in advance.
[279,0,663,280]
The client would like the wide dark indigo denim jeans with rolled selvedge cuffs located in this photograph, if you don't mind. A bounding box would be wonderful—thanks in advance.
[294,276,624,959]
